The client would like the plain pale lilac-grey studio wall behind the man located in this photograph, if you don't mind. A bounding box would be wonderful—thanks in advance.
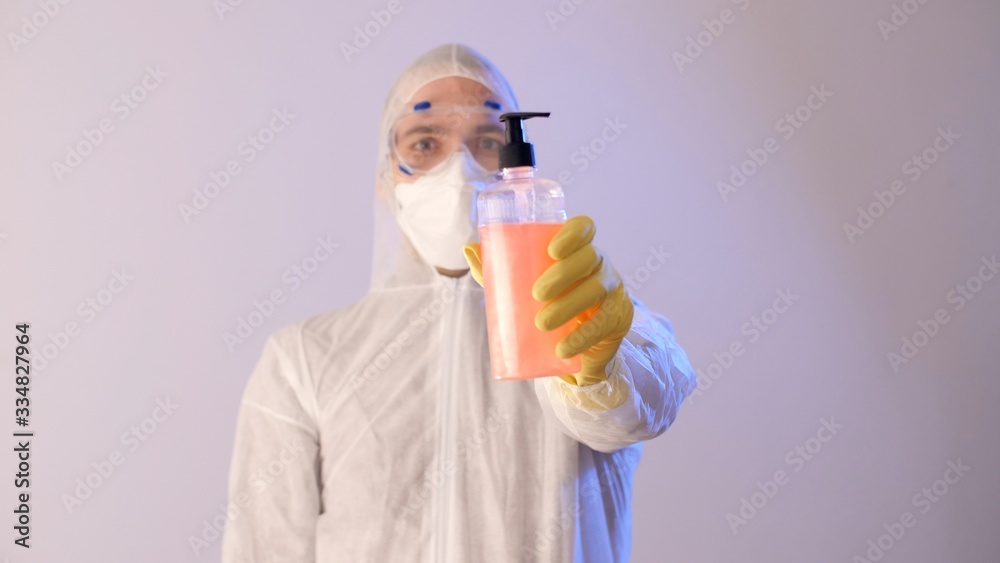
[0,0,1000,563]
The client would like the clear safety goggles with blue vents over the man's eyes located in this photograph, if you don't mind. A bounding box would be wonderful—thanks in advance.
[390,101,504,175]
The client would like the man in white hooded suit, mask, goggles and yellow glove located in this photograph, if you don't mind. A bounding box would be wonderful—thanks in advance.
[222,45,695,563]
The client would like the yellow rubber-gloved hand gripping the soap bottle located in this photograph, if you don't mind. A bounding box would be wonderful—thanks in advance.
[462,215,633,386]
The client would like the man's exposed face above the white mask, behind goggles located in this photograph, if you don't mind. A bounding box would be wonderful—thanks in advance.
[391,76,500,183]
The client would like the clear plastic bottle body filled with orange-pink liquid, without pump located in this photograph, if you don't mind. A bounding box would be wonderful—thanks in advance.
[477,166,580,379]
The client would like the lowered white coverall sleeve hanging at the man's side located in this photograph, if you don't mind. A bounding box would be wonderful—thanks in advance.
[222,327,321,563]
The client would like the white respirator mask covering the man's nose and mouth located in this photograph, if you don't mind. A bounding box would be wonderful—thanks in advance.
[396,147,495,270]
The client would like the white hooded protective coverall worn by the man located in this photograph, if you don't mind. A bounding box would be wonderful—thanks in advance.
[222,45,695,563]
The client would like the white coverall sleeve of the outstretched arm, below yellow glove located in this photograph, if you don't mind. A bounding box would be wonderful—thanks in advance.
[535,297,696,453]
